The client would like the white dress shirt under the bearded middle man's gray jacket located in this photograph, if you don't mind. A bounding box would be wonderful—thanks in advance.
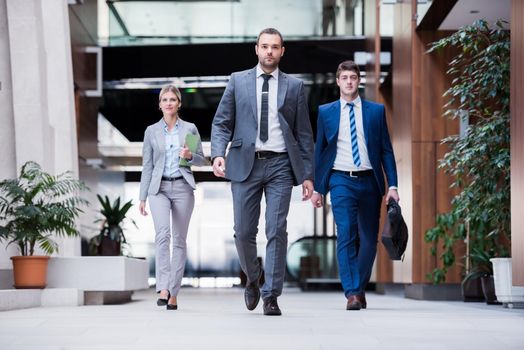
[255,64,286,152]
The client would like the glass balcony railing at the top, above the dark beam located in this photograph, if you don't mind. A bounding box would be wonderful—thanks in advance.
[98,0,363,46]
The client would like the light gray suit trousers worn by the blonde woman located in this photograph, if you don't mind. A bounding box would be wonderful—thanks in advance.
[149,179,195,296]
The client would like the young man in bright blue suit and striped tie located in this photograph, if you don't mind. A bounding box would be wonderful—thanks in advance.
[311,61,399,310]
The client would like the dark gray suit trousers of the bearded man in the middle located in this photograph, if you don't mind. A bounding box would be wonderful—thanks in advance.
[231,155,293,298]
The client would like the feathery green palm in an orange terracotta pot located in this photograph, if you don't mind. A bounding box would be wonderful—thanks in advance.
[0,161,87,288]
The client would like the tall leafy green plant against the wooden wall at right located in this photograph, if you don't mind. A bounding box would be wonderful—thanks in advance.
[425,20,511,298]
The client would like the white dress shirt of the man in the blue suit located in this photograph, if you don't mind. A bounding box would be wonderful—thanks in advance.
[333,96,373,171]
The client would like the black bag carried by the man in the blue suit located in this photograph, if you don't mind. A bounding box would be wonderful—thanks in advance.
[382,198,408,260]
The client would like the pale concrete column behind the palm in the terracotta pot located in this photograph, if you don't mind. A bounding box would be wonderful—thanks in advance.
[0,0,80,268]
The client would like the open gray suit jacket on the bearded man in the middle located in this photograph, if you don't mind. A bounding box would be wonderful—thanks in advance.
[211,68,313,185]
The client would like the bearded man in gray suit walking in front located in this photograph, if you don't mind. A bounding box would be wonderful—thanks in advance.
[211,28,313,315]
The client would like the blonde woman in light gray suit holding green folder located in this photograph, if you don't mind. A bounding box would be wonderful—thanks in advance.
[139,85,204,310]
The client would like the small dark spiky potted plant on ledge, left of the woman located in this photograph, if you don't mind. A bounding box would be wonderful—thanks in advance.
[89,195,136,256]
